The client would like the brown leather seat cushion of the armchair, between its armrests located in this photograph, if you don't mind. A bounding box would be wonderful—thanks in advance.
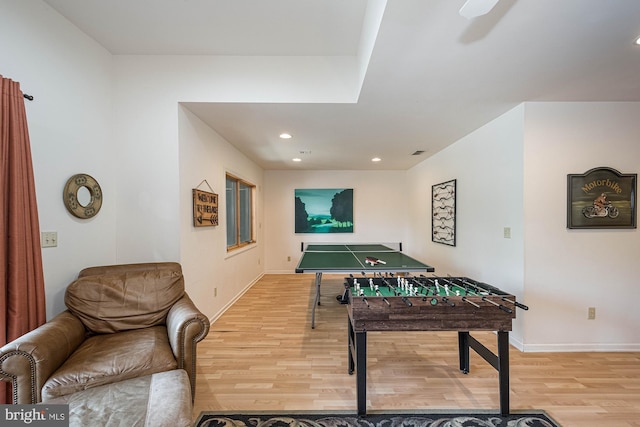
[42,326,178,402]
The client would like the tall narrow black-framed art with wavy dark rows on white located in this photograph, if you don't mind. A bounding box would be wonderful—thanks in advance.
[431,179,456,246]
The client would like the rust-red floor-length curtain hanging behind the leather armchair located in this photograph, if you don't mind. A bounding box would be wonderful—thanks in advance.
[0,75,46,403]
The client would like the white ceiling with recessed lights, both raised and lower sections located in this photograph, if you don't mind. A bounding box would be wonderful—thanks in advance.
[45,0,640,170]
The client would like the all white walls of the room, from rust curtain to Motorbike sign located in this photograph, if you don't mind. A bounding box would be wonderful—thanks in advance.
[5,0,640,351]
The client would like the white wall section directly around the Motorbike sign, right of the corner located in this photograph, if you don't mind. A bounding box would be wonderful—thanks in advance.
[524,102,640,351]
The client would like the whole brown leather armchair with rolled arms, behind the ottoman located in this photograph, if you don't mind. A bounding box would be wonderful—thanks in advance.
[0,263,210,404]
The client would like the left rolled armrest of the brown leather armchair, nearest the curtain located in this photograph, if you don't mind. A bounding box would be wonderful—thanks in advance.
[0,311,85,404]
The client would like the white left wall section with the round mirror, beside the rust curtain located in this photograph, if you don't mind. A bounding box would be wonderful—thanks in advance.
[0,0,117,317]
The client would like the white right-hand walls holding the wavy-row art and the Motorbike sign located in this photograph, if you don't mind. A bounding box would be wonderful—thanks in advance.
[406,102,640,351]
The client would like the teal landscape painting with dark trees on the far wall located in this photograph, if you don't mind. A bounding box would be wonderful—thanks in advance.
[294,188,353,233]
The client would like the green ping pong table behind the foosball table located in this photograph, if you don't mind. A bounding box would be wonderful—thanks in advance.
[296,243,435,328]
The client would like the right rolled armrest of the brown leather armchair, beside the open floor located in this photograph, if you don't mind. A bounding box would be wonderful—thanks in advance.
[167,293,210,400]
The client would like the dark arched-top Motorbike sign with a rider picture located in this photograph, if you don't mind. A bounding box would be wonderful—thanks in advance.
[567,167,638,228]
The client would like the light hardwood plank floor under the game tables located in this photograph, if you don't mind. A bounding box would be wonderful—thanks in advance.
[194,274,640,427]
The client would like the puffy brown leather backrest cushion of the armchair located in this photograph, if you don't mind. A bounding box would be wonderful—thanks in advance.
[64,262,184,334]
